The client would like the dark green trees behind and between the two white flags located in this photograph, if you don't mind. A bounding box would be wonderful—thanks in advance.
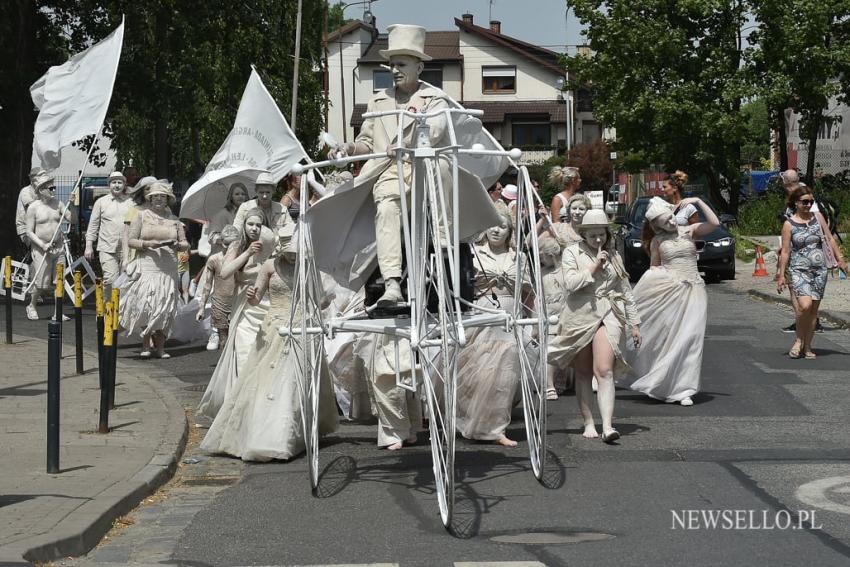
[44,0,325,177]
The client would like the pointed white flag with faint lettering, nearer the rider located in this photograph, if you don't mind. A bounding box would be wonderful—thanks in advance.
[180,68,307,220]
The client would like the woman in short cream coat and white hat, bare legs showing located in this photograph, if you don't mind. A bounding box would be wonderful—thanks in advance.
[549,210,641,443]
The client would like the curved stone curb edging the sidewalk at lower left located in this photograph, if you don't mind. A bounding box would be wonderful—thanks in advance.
[0,352,189,565]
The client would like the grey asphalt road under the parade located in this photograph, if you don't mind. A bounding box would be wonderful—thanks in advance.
[41,284,850,566]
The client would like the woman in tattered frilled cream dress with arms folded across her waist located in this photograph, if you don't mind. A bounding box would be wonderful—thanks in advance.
[118,184,189,358]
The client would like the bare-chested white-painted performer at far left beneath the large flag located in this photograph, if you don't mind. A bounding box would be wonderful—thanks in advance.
[26,174,71,321]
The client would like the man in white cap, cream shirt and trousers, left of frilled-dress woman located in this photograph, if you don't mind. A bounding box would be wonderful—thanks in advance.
[85,171,132,297]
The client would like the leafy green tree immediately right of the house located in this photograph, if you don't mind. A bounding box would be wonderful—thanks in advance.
[564,0,746,212]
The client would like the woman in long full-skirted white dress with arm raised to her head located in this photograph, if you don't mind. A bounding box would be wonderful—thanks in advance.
[618,198,720,406]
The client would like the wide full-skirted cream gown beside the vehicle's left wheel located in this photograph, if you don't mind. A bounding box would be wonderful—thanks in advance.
[201,262,337,461]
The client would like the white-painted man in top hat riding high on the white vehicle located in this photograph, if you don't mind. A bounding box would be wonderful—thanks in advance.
[330,24,451,307]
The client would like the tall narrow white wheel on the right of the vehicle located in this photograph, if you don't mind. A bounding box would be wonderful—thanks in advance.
[513,166,549,480]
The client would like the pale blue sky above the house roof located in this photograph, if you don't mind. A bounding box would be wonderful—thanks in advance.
[345,0,582,52]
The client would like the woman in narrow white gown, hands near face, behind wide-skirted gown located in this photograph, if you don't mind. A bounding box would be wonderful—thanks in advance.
[198,209,277,417]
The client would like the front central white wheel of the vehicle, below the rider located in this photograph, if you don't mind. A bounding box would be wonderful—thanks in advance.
[410,161,460,529]
